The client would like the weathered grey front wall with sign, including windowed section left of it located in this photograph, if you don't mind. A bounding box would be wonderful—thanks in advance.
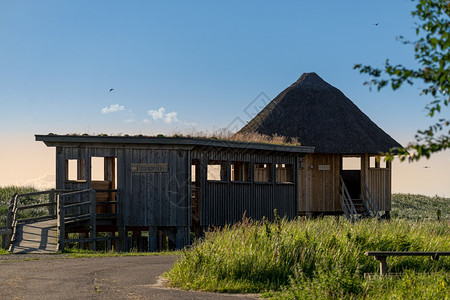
[56,147,190,227]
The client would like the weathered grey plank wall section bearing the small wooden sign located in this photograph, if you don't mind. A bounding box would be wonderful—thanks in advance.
[117,149,191,226]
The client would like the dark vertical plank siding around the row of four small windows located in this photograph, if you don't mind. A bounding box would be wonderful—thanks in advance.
[192,149,297,226]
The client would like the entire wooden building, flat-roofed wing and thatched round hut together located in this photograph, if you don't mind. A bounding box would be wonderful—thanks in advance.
[36,73,401,251]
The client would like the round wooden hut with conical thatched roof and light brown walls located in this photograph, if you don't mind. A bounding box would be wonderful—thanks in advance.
[238,73,401,218]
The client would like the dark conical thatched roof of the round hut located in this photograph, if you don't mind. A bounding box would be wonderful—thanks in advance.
[239,73,401,154]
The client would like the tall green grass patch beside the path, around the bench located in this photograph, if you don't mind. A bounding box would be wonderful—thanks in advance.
[165,218,450,299]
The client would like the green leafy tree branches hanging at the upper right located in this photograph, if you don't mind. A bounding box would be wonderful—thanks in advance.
[353,0,450,160]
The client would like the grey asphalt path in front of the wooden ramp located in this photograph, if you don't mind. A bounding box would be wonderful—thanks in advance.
[0,254,256,300]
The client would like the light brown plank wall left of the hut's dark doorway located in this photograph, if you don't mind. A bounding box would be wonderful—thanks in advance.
[298,154,342,214]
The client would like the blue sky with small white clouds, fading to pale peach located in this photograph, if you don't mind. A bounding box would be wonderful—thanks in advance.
[0,0,450,195]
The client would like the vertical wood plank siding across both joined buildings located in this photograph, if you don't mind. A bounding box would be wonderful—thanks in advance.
[52,145,392,227]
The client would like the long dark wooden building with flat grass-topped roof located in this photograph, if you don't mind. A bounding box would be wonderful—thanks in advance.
[36,135,314,251]
